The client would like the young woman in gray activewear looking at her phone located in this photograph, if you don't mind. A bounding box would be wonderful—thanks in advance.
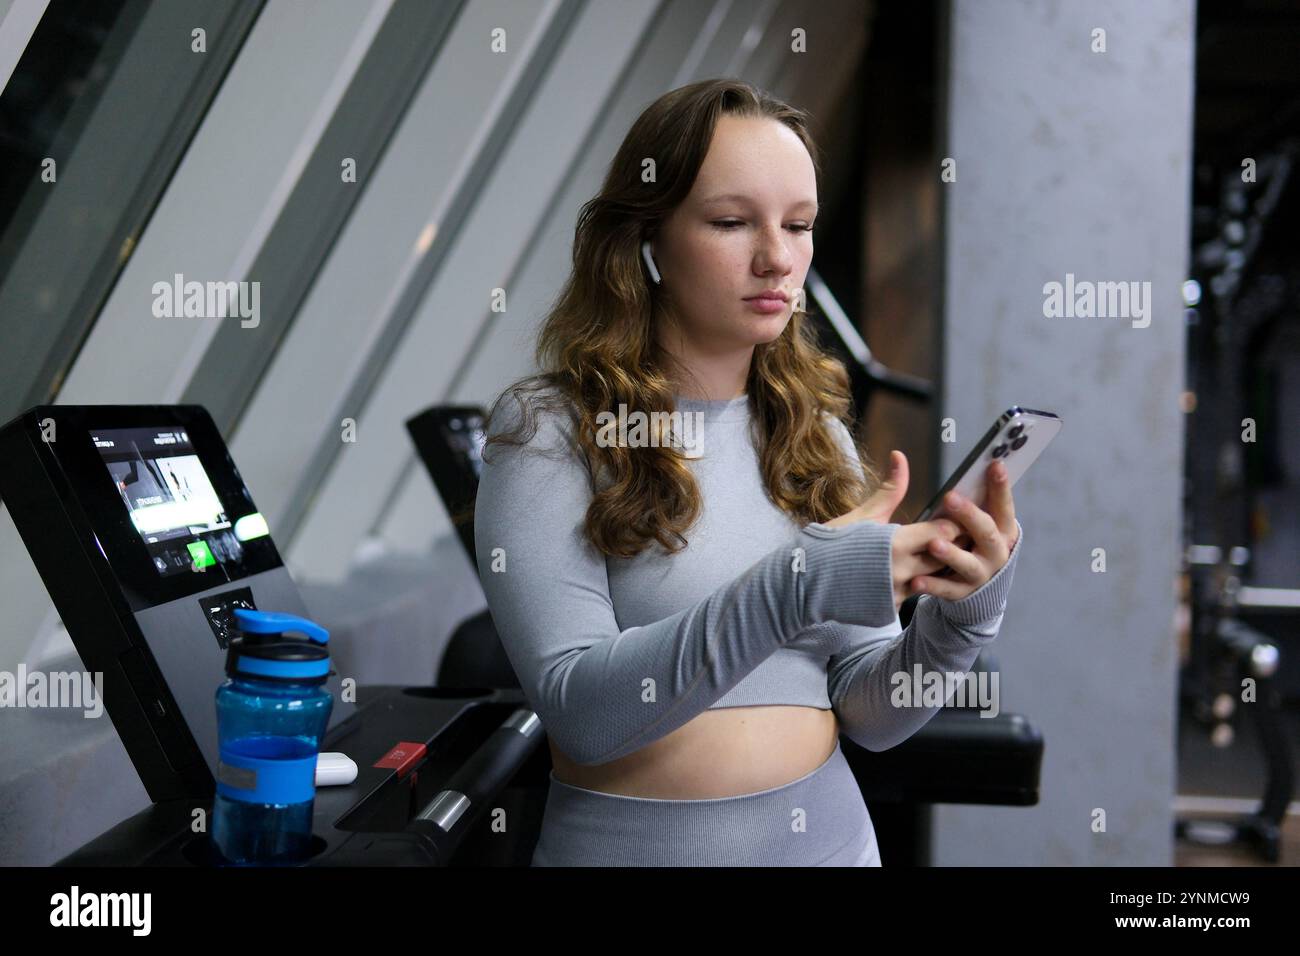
[475,79,1021,866]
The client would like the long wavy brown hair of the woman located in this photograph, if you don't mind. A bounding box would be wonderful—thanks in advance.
[459,79,879,558]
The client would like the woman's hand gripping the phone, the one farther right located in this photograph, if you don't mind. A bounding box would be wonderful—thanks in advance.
[911,462,1021,601]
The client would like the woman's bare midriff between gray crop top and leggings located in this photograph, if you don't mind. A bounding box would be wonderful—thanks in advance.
[550,704,840,800]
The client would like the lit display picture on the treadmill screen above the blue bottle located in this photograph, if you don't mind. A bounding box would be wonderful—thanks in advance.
[91,428,243,576]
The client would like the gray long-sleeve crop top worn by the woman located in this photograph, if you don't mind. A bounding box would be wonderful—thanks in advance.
[475,393,1024,765]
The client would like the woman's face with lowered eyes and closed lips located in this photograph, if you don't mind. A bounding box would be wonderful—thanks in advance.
[650,114,816,355]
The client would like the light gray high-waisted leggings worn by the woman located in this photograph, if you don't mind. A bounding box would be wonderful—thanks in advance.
[533,741,880,866]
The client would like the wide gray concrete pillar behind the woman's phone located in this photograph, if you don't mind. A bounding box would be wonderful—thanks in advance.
[933,0,1195,866]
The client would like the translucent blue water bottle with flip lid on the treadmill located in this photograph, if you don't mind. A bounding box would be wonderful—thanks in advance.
[212,607,334,864]
